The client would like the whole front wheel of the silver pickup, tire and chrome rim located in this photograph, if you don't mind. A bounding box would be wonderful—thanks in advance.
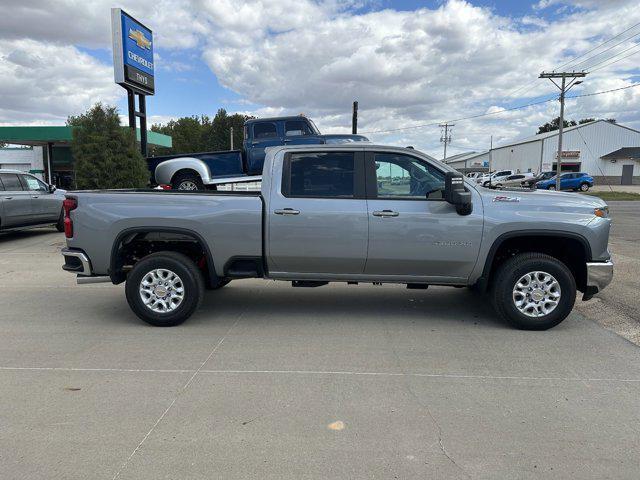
[491,252,576,330]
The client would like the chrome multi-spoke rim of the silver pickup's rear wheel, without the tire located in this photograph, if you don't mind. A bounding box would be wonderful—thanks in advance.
[139,268,184,313]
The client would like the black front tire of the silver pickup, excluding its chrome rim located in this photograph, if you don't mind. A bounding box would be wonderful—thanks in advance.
[491,252,576,330]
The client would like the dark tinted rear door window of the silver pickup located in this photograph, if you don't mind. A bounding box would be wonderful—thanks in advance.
[282,152,355,198]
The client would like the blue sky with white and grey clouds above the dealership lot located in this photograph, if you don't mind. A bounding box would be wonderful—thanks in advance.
[0,0,640,158]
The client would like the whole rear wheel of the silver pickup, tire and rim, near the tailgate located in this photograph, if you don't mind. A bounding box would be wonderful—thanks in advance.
[125,252,204,327]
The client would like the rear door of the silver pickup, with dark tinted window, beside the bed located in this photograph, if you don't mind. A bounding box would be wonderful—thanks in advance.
[266,150,368,279]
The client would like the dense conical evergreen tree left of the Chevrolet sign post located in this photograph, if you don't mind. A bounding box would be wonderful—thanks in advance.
[67,103,149,189]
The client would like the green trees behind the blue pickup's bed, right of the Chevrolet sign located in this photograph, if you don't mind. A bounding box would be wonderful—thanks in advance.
[151,108,252,155]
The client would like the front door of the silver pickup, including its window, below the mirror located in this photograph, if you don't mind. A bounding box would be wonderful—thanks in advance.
[365,152,482,281]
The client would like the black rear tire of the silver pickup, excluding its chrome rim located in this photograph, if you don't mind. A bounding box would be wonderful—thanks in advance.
[125,252,204,327]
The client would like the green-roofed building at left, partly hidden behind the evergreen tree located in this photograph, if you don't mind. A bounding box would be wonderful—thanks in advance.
[0,126,172,189]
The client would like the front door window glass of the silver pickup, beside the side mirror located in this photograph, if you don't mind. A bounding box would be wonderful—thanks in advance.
[374,153,444,200]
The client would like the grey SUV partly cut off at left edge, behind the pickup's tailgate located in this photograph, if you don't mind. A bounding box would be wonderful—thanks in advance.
[0,169,65,232]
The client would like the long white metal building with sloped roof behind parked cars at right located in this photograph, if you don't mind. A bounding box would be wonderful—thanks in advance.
[446,120,640,185]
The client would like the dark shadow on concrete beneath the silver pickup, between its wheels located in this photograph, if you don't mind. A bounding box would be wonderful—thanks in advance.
[195,282,506,328]
